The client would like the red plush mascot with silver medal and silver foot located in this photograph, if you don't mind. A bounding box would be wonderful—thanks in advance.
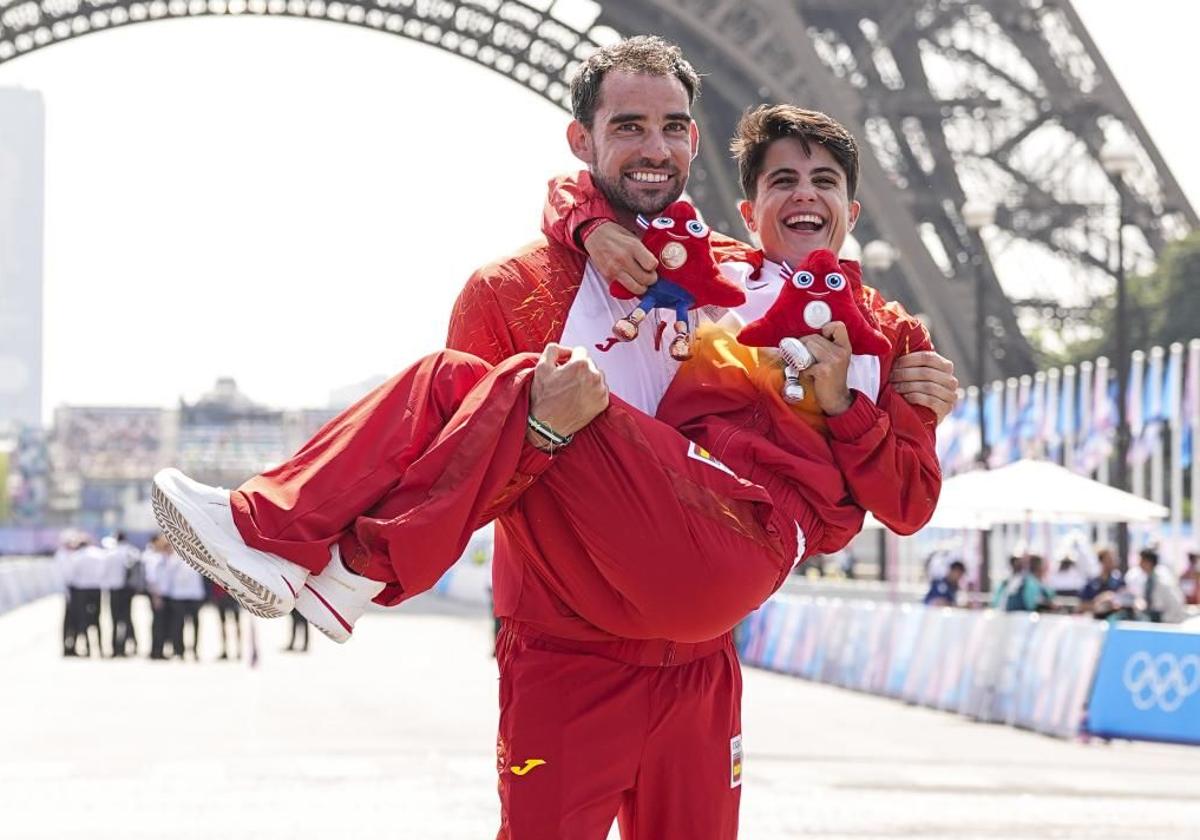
[738,248,890,402]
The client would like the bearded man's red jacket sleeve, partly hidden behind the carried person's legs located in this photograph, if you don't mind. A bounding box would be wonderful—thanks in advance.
[446,266,554,528]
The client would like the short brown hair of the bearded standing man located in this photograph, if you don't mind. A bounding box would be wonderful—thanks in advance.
[571,35,700,128]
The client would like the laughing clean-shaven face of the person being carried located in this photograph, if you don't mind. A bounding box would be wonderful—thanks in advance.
[738,137,859,265]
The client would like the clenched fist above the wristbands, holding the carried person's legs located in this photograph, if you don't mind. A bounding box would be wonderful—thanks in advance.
[529,344,608,443]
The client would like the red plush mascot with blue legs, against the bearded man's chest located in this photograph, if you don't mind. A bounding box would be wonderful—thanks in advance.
[611,202,746,361]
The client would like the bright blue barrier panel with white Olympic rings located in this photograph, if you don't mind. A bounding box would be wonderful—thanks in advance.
[1087,624,1200,744]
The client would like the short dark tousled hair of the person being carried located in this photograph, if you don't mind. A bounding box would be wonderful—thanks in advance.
[730,104,858,200]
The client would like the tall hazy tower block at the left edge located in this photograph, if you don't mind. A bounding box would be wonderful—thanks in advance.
[0,88,46,427]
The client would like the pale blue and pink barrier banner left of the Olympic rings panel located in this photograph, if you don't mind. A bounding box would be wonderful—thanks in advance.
[738,594,1108,737]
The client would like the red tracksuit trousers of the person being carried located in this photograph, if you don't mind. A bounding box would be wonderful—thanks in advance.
[233,350,796,642]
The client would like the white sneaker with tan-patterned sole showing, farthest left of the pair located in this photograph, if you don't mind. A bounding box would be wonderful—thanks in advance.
[150,469,308,618]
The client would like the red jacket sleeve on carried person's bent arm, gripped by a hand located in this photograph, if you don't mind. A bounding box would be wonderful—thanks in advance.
[829,290,942,534]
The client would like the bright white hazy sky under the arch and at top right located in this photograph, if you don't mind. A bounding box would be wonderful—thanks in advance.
[0,0,1200,414]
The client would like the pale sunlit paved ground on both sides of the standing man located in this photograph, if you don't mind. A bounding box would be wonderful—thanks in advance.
[0,599,1200,840]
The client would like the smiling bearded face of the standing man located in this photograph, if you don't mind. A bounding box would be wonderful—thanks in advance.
[568,71,700,221]
